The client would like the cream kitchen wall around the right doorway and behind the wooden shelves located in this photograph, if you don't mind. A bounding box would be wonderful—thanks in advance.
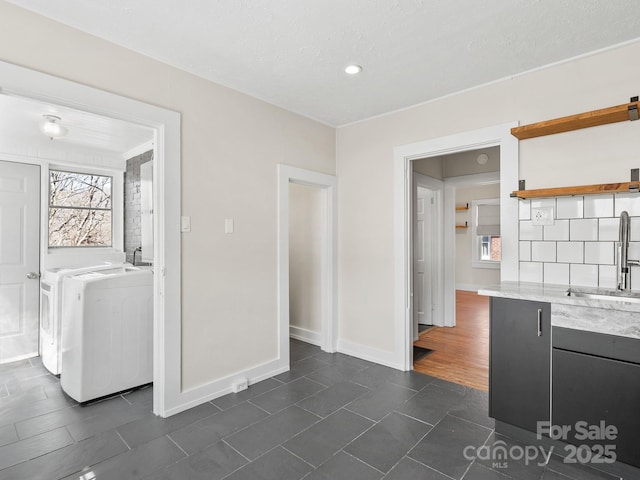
[338,43,640,352]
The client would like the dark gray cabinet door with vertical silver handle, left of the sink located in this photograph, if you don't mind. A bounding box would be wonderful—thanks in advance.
[489,297,551,432]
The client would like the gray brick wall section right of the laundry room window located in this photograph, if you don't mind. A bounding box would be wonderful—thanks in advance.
[124,150,153,265]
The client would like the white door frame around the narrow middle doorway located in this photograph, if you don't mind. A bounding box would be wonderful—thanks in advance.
[278,164,338,360]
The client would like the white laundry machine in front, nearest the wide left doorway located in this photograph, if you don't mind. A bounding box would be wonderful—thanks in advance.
[60,267,153,402]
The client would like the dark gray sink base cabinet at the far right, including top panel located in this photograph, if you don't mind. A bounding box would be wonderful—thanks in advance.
[552,328,640,466]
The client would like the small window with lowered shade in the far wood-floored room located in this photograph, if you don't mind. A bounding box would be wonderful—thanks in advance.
[471,198,501,268]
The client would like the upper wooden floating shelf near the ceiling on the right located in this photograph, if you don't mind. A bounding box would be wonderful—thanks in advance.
[511,98,640,140]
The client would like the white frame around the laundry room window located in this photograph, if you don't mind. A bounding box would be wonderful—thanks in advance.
[47,164,124,254]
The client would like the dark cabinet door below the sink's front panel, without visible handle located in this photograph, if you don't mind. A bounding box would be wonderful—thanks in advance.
[552,348,640,466]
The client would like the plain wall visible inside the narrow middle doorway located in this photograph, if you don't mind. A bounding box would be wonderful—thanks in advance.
[289,183,322,343]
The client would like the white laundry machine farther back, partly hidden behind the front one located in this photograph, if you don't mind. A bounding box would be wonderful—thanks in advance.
[40,263,130,375]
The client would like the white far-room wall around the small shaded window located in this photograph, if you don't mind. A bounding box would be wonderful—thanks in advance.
[456,183,500,290]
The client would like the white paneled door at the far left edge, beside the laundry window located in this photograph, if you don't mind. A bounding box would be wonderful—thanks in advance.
[0,161,40,363]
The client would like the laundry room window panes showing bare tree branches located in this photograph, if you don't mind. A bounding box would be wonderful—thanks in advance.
[49,170,113,247]
